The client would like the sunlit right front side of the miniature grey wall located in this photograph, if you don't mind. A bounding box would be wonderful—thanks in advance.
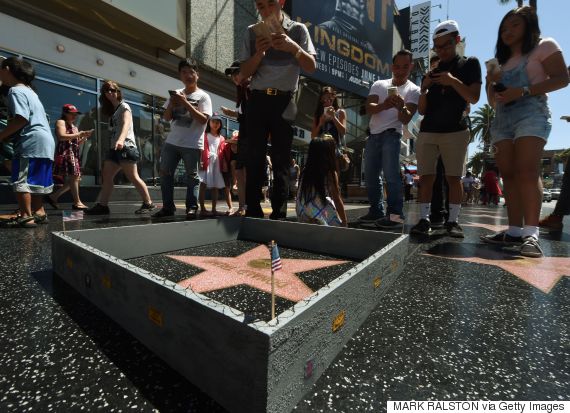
[262,236,407,412]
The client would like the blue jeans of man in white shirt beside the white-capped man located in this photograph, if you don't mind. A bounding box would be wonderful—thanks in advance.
[364,129,404,218]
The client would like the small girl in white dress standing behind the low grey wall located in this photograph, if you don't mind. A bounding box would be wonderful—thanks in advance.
[198,114,232,217]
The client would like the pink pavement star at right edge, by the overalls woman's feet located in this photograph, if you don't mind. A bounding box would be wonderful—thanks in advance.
[430,254,570,294]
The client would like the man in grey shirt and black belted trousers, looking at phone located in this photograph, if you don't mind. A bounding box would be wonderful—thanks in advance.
[236,0,316,219]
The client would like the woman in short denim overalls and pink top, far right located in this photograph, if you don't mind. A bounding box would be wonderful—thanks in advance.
[481,7,568,257]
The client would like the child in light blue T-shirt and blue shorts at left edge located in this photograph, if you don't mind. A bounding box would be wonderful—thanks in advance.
[0,57,55,228]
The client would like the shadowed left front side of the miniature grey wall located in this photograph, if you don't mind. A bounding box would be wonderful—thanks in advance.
[53,229,269,412]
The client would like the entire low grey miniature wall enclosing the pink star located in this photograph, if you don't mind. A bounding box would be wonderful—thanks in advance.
[52,218,407,412]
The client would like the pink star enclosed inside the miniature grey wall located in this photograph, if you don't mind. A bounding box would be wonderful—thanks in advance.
[168,245,347,302]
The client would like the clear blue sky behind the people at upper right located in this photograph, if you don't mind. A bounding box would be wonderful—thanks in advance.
[395,0,570,156]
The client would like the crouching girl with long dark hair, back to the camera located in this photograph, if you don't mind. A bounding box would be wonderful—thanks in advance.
[296,134,347,227]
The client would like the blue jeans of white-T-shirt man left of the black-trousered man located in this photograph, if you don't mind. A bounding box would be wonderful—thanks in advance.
[160,143,201,211]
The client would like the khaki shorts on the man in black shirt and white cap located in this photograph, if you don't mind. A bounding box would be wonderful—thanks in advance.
[416,130,470,176]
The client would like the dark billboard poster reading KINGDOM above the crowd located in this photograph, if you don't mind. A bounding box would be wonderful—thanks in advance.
[291,0,394,96]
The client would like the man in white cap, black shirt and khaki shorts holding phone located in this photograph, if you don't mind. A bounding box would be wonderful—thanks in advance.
[410,20,482,238]
